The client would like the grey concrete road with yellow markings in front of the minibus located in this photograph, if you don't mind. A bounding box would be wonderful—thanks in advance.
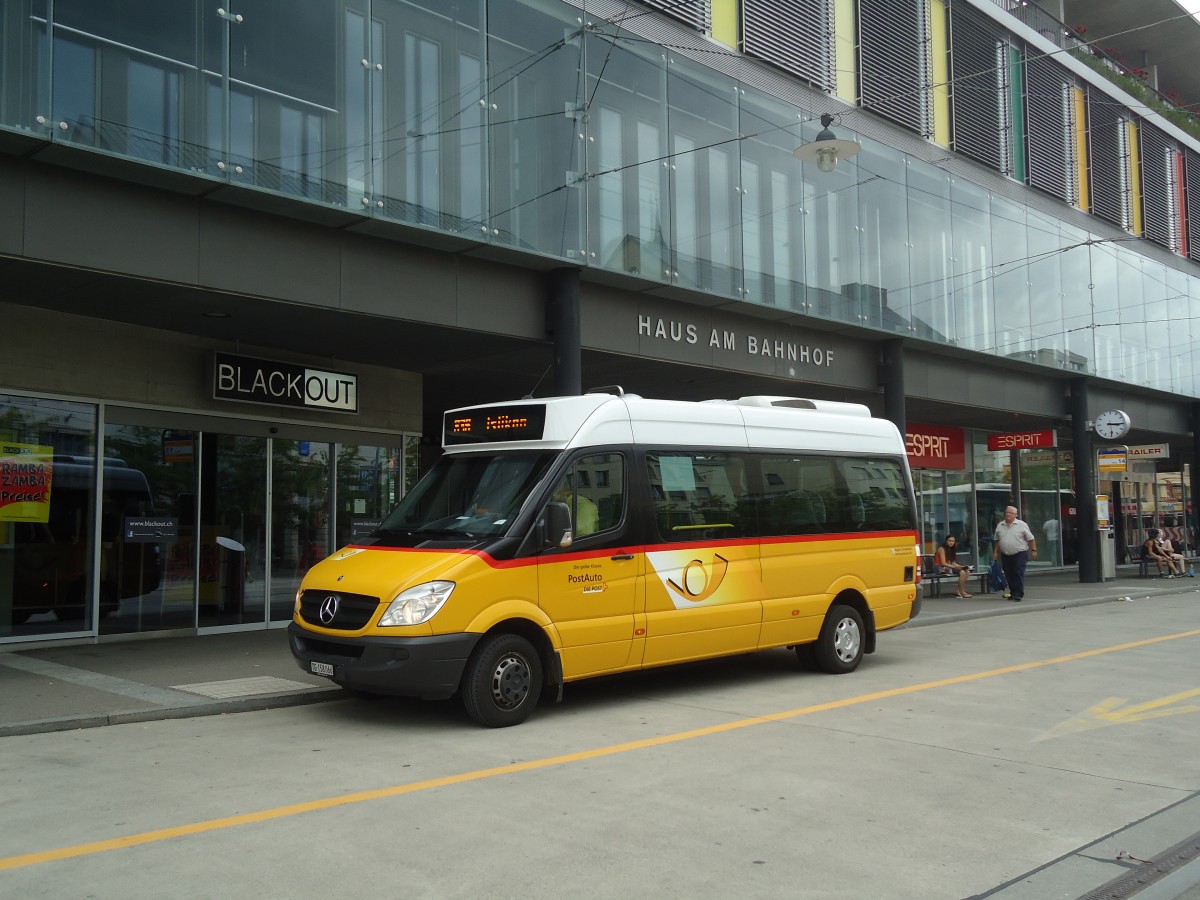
[0,592,1200,900]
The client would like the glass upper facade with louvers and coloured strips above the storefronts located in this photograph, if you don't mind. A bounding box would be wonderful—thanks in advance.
[7,0,1200,397]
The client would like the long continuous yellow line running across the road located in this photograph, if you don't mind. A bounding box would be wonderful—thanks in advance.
[0,629,1200,871]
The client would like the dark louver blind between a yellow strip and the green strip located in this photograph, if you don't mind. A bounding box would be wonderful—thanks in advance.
[950,4,1008,175]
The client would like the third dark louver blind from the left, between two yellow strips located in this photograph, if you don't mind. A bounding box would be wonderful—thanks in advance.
[858,0,932,138]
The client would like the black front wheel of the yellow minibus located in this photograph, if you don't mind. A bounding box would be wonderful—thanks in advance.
[462,635,541,728]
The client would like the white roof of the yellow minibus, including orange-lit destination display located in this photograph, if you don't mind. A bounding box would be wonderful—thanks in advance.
[443,394,905,456]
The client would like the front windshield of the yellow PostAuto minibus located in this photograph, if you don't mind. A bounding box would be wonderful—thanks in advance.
[379,451,556,539]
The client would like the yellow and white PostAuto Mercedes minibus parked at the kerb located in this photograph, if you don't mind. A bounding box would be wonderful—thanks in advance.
[288,388,920,727]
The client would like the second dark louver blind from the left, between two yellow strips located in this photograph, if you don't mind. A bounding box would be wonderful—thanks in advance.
[742,0,835,91]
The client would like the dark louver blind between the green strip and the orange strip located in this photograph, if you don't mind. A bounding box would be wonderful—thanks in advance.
[1025,56,1079,204]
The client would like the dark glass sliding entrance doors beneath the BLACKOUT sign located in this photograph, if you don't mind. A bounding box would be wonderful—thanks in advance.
[94,408,416,634]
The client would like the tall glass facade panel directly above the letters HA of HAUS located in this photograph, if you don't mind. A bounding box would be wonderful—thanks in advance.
[586,27,670,281]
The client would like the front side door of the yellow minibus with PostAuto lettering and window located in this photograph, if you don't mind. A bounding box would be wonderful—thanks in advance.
[538,454,644,680]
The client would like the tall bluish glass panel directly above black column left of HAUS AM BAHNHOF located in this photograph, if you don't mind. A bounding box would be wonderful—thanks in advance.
[487,0,586,257]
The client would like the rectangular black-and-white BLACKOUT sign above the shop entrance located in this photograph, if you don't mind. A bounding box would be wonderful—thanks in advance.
[212,353,359,413]
